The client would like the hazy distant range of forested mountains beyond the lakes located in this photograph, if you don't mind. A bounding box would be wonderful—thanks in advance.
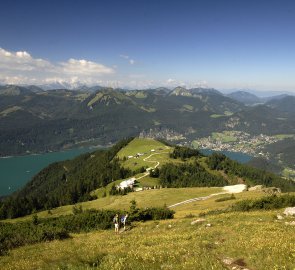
[0,85,295,156]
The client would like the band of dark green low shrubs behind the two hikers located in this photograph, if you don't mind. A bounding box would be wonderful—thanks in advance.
[0,204,174,256]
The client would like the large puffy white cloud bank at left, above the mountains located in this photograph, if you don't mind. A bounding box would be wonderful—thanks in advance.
[0,48,115,84]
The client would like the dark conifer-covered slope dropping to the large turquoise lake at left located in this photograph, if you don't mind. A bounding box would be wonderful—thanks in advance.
[0,138,132,218]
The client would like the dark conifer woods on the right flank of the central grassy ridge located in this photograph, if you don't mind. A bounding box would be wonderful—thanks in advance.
[158,146,295,192]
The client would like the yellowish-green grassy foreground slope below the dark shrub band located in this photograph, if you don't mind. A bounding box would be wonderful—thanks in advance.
[0,192,295,270]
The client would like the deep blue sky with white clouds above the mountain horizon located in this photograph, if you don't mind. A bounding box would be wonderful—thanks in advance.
[0,0,295,92]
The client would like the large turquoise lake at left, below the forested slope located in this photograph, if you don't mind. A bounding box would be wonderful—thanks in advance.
[0,148,95,196]
